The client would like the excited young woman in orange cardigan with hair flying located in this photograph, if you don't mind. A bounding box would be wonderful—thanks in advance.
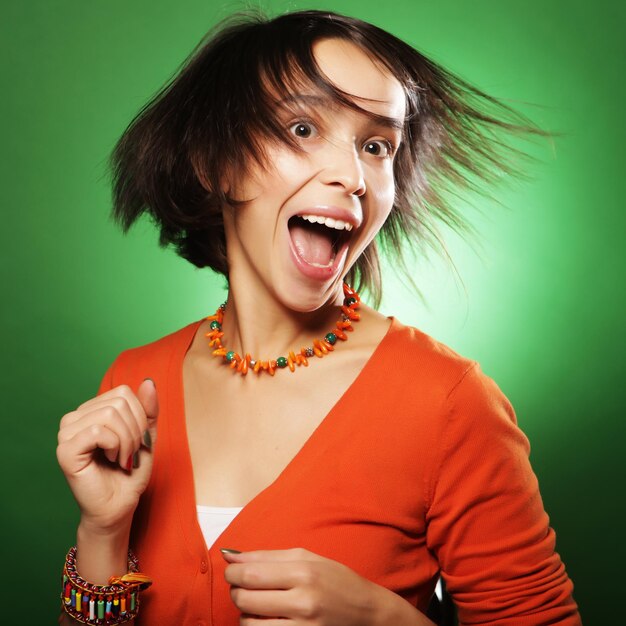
[58,11,580,626]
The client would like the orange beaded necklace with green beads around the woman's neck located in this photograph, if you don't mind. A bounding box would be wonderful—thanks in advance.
[205,283,361,376]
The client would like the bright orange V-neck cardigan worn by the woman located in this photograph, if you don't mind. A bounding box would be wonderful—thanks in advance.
[99,318,581,626]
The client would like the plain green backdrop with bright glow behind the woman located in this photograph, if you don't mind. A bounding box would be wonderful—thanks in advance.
[0,0,626,624]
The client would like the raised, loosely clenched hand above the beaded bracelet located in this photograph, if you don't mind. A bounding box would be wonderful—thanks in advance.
[57,378,159,532]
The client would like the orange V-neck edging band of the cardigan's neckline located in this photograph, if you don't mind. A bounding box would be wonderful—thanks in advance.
[165,316,401,554]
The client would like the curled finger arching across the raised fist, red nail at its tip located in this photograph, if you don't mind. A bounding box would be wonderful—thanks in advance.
[59,406,136,470]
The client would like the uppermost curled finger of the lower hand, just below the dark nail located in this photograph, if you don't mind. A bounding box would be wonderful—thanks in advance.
[224,561,316,589]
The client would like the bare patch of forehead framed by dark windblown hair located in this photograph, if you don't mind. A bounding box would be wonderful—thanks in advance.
[313,39,406,120]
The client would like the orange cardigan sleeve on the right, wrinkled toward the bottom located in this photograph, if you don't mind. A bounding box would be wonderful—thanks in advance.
[426,363,581,626]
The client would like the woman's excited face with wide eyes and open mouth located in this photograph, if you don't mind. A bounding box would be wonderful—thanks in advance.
[224,39,406,311]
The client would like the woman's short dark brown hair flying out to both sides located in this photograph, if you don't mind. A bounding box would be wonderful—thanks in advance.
[110,11,546,306]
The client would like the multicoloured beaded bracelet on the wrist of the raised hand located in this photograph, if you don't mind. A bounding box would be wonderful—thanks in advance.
[61,546,152,626]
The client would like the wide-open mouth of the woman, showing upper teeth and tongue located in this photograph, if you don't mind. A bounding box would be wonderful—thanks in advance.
[287,215,352,268]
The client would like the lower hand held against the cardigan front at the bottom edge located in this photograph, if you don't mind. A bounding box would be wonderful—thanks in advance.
[223,548,422,626]
